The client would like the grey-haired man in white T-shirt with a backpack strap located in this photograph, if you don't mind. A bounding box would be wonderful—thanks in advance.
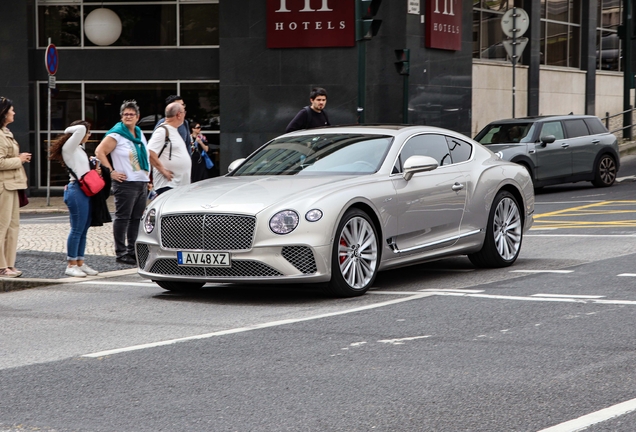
[148,102,192,195]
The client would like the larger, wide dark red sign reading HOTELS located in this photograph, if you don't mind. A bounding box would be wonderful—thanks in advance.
[267,0,355,48]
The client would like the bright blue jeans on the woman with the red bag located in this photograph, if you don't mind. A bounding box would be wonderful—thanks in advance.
[64,182,91,261]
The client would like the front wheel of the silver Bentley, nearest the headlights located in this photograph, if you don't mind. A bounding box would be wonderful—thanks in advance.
[326,209,380,297]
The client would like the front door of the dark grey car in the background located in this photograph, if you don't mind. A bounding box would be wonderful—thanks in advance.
[535,121,572,180]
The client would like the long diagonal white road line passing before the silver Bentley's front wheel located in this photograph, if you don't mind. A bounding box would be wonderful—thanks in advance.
[82,293,433,358]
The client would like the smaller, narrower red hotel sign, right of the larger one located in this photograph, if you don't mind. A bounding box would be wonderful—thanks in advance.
[424,0,462,51]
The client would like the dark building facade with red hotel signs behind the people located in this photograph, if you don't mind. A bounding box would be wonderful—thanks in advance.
[0,0,624,193]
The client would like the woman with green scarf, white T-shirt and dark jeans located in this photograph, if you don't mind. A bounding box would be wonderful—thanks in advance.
[95,100,150,265]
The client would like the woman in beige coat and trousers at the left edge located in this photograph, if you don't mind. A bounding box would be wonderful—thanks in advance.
[0,96,31,277]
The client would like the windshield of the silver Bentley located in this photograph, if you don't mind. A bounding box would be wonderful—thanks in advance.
[230,133,393,176]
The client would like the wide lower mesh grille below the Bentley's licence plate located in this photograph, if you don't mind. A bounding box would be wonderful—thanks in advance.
[150,259,282,278]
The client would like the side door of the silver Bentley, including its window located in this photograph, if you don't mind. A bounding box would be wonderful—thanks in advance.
[393,134,466,253]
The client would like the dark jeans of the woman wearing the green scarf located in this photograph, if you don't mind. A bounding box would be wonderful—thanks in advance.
[113,181,148,258]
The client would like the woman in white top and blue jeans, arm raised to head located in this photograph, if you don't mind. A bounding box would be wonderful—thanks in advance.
[49,120,98,277]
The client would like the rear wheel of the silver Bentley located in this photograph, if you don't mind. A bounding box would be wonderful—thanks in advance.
[468,191,523,268]
